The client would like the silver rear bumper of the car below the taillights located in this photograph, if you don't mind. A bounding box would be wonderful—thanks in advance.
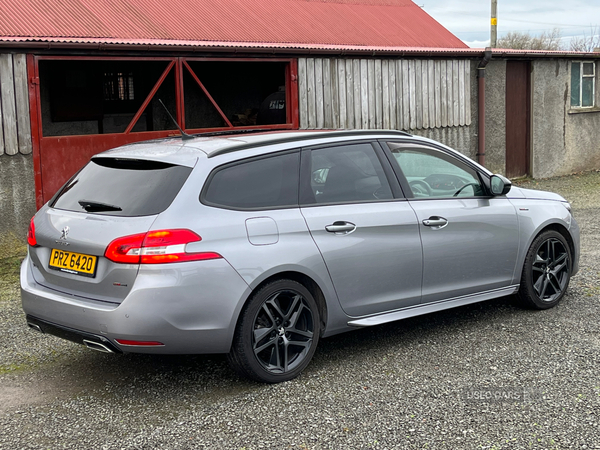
[21,253,250,354]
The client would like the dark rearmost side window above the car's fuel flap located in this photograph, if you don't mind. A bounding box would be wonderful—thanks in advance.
[201,152,300,209]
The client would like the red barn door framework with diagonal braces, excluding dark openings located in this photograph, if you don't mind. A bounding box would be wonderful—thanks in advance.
[27,54,299,209]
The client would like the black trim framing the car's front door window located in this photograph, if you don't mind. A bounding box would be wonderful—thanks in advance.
[379,139,494,201]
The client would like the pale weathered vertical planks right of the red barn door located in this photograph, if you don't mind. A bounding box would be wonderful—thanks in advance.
[298,58,471,130]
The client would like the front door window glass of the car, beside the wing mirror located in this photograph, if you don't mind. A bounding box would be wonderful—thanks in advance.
[388,142,485,198]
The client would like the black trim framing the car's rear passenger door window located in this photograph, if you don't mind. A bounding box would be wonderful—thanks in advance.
[299,138,407,208]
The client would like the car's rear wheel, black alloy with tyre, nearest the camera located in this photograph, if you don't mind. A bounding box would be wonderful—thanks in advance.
[228,280,320,383]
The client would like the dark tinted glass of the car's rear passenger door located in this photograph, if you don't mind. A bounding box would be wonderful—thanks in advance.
[311,144,393,203]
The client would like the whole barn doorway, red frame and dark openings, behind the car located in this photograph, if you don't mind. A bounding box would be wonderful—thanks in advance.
[28,55,298,208]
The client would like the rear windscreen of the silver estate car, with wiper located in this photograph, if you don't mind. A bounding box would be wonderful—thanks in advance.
[50,158,192,217]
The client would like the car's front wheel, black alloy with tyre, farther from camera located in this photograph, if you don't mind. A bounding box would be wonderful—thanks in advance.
[518,230,572,309]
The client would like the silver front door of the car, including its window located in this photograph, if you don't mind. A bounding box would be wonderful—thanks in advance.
[388,142,519,303]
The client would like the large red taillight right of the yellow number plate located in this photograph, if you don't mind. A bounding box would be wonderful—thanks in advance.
[104,230,222,264]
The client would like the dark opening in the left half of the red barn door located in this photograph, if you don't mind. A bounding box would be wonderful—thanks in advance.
[39,59,177,136]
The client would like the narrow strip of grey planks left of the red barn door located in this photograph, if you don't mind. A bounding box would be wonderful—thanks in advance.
[0,53,32,155]
